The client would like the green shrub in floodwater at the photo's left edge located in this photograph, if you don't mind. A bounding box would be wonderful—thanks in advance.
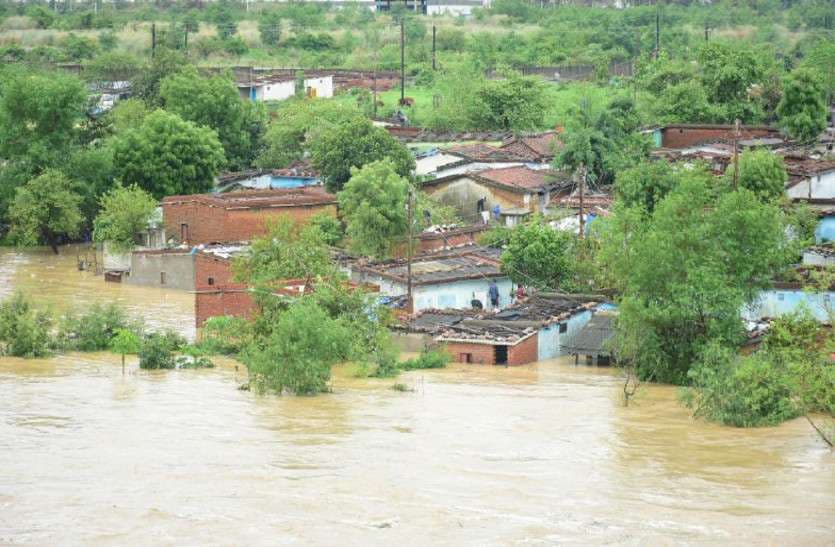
[0,292,52,357]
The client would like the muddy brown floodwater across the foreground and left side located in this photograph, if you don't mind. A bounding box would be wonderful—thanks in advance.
[0,250,835,546]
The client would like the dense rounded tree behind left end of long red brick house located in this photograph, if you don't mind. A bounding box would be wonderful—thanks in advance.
[113,110,224,199]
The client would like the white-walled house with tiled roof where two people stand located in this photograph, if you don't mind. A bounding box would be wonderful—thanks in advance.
[343,246,513,311]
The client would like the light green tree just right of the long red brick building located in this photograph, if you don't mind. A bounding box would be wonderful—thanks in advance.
[338,159,410,258]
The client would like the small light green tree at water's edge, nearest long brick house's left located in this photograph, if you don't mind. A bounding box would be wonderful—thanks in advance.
[93,184,157,251]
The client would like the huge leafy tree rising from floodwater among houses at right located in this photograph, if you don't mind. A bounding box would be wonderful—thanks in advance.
[601,173,787,384]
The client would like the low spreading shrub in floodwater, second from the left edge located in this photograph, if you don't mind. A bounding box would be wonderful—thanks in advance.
[58,303,141,351]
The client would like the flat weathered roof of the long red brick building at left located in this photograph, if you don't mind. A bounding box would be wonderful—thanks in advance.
[162,186,336,209]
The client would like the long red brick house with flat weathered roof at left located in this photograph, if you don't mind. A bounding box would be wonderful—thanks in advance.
[162,186,337,245]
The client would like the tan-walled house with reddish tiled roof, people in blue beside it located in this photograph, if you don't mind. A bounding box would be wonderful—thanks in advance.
[422,165,570,222]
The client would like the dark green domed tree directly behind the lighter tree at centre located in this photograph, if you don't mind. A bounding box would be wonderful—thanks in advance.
[310,119,415,192]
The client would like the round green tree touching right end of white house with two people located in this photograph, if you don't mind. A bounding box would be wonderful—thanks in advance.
[501,217,573,290]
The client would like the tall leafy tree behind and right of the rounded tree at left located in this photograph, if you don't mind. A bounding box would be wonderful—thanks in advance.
[160,68,266,169]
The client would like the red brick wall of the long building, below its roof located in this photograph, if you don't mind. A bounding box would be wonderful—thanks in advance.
[162,202,336,245]
